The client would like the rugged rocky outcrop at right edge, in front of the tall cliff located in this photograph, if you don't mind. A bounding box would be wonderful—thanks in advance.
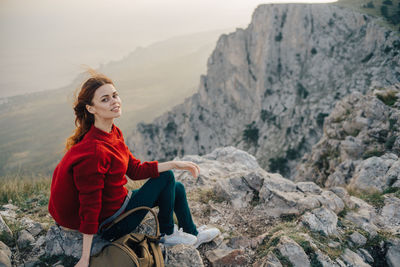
[296,84,400,192]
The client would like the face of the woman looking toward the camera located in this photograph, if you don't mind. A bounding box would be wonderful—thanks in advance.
[86,84,121,120]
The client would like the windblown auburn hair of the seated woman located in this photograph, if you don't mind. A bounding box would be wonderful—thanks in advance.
[65,69,114,151]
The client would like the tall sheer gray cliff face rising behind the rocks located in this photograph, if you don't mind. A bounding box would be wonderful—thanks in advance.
[128,4,400,176]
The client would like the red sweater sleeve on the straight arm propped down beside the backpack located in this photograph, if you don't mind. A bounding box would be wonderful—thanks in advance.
[73,148,107,234]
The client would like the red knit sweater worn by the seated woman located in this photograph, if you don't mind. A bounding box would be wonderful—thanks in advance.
[49,125,159,234]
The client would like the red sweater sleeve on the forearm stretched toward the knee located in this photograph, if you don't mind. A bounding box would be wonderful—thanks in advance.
[126,150,160,180]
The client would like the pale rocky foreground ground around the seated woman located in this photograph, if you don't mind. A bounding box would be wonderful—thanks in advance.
[0,147,400,266]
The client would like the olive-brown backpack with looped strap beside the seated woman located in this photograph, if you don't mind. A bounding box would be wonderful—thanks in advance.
[89,207,164,267]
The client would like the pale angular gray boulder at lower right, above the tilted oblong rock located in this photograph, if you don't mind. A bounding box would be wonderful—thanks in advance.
[301,207,338,235]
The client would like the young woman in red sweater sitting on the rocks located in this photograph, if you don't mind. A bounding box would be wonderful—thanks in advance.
[49,71,219,266]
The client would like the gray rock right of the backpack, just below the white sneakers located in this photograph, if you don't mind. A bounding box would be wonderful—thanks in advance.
[165,245,204,267]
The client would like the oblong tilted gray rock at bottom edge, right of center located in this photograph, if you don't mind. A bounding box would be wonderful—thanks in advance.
[278,236,310,267]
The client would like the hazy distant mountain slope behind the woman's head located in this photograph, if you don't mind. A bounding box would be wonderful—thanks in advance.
[0,29,229,177]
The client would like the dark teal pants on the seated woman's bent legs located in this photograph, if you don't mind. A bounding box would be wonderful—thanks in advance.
[102,170,198,243]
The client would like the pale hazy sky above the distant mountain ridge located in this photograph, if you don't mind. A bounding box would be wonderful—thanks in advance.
[0,0,338,97]
